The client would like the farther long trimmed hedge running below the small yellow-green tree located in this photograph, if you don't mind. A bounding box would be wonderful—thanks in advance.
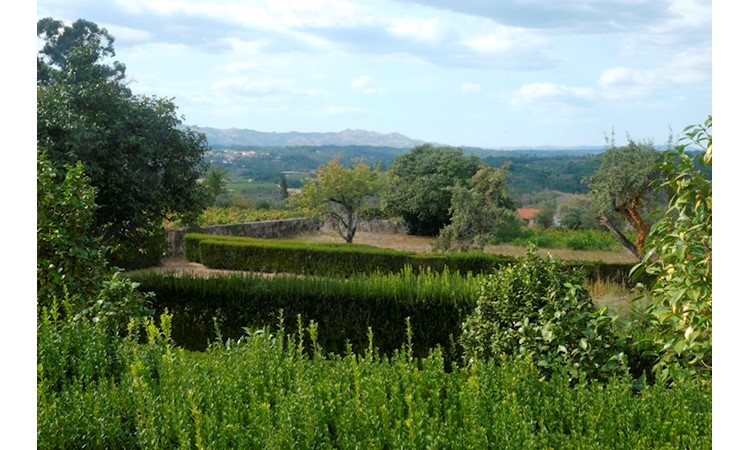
[184,234,648,284]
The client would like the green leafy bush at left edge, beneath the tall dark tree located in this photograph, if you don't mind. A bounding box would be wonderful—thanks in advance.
[37,150,150,332]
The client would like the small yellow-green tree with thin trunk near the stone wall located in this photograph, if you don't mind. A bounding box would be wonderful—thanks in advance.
[291,157,384,244]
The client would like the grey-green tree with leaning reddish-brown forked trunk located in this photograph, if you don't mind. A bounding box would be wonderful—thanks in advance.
[588,140,662,259]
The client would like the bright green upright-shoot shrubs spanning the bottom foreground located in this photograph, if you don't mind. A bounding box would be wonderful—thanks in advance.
[37,314,712,450]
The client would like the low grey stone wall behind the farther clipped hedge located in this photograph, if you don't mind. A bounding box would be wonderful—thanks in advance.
[167,218,321,256]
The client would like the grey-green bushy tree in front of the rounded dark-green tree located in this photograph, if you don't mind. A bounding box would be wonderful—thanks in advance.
[433,166,516,251]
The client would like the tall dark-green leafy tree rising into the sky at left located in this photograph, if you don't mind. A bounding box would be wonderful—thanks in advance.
[37,19,209,268]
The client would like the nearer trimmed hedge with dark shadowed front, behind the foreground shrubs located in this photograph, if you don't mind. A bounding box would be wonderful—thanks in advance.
[131,269,476,355]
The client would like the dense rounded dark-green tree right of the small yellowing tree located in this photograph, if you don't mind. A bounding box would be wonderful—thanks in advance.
[383,144,483,236]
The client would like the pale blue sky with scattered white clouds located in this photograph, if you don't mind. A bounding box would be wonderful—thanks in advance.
[36,0,712,148]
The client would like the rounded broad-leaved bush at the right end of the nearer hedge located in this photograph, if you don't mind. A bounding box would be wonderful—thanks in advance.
[459,246,627,381]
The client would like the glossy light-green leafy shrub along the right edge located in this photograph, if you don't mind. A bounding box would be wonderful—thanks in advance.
[635,116,713,381]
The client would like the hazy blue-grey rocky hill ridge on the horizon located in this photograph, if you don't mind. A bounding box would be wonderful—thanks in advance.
[193,127,425,149]
